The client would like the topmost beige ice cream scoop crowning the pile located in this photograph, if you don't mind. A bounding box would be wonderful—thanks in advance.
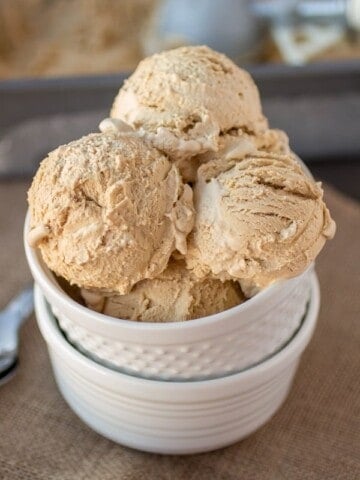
[111,47,288,181]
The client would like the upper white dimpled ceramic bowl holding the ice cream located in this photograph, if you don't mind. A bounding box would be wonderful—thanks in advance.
[25,212,312,380]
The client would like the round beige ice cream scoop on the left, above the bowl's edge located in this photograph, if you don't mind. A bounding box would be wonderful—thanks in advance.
[28,134,194,294]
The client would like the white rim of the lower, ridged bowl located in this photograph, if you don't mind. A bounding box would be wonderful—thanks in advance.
[34,272,320,389]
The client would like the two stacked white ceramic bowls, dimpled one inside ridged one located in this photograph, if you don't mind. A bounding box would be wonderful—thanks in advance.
[25,219,320,454]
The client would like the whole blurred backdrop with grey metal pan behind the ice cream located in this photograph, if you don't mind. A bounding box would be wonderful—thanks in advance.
[0,0,360,197]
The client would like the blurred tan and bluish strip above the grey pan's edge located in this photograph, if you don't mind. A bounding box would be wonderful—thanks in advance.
[0,0,360,79]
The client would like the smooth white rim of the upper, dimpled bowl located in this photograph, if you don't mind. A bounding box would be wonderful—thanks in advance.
[23,210,314,332]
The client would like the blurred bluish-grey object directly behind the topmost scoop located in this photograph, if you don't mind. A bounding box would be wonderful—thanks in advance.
[143,0,264,60]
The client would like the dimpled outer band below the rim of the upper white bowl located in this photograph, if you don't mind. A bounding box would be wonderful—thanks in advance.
[52,275,310,380]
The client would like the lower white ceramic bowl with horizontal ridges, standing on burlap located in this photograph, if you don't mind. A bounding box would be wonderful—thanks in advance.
[35,273,319,454]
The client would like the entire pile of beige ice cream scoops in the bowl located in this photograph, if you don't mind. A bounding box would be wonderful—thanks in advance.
[28,47,335,322]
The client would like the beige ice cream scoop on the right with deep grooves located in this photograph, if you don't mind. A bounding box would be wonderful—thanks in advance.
[187,152,335,294]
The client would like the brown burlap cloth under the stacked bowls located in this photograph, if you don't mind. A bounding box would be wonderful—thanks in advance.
[0,182,360,480]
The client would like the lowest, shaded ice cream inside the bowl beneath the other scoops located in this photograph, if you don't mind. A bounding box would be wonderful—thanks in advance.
[81,260,244,322]
